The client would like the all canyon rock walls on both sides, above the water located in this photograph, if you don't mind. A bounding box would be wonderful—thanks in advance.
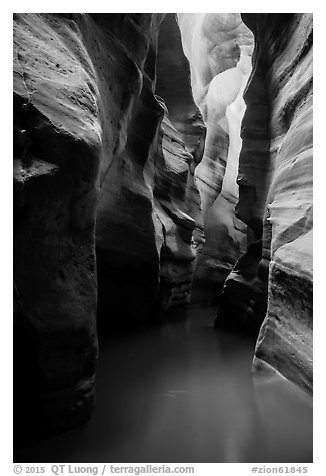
[14,13,312,434]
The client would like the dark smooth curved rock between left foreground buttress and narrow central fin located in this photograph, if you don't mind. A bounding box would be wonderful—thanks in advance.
[96,14,163,327]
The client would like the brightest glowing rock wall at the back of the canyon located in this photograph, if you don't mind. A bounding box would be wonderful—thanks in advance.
[178,13,253,303]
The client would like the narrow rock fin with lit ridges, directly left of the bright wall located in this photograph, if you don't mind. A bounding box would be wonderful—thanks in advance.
[154,14,206,310]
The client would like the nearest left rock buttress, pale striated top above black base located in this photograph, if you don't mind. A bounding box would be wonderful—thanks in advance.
[14,14,101,433]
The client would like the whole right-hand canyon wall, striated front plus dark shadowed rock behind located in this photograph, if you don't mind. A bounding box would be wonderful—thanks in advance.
[217,14,312,392]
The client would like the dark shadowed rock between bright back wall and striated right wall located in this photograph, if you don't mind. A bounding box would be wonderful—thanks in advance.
[215,13,270,333]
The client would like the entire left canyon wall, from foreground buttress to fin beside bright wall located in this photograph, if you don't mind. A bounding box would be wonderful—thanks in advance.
[14,14,205,433]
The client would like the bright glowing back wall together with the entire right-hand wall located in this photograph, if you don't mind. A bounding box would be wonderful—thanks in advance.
[178,14,312,392]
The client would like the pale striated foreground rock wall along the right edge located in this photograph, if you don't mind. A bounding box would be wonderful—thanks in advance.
[250,13,313,392]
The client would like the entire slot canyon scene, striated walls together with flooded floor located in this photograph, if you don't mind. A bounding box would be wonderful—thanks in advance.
[13,13,313,463]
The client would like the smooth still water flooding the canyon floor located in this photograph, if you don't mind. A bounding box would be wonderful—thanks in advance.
[14,308,312,463]
